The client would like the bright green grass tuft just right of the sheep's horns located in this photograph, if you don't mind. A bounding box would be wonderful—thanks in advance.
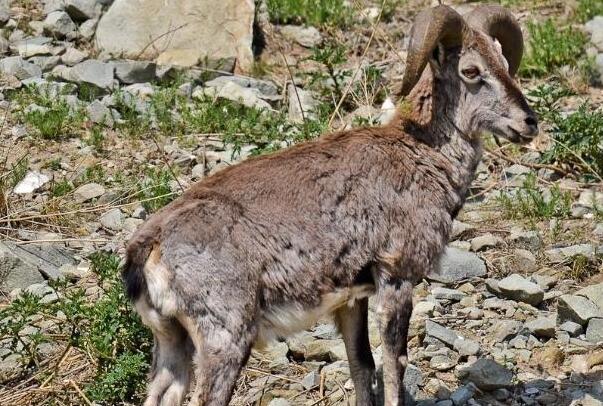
[519,19,587,77]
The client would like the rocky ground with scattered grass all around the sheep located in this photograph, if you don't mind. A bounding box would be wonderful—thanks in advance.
[0,0,603,406]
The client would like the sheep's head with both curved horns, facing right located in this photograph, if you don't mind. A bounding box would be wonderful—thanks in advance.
[401,5,538,143]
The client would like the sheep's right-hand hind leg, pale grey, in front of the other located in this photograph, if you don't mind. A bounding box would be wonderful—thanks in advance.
[183,315,255,406]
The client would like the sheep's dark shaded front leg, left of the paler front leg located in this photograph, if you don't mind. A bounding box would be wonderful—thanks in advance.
[335,298,377,406]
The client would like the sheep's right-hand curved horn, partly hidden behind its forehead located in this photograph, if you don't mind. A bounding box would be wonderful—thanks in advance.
[465,4,523,76]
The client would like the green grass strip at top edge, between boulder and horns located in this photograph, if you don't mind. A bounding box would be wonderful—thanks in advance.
[267,0,353,28]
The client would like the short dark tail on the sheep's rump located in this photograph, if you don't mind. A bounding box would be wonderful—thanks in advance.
[121,232,155,302]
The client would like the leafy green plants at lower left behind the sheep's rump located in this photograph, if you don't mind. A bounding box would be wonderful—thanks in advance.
[0,252,152,404]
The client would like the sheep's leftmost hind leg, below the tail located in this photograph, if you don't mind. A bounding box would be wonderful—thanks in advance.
[136,302,194,406]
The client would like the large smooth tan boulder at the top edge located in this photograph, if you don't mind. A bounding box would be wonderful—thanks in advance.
[96,0,255,70]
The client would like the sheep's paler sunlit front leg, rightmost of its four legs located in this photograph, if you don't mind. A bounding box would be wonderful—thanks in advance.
[377,279,412,406]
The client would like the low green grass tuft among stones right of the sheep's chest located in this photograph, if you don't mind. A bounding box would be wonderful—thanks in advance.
[497,173,572,221]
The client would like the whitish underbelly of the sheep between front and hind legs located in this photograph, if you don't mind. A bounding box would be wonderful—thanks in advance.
[254,284,375,348]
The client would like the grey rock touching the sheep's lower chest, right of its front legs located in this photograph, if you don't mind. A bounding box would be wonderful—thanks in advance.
[429,247,486,283]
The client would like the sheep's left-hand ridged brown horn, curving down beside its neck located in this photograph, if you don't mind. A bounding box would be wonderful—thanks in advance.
[400,6,465,96]
